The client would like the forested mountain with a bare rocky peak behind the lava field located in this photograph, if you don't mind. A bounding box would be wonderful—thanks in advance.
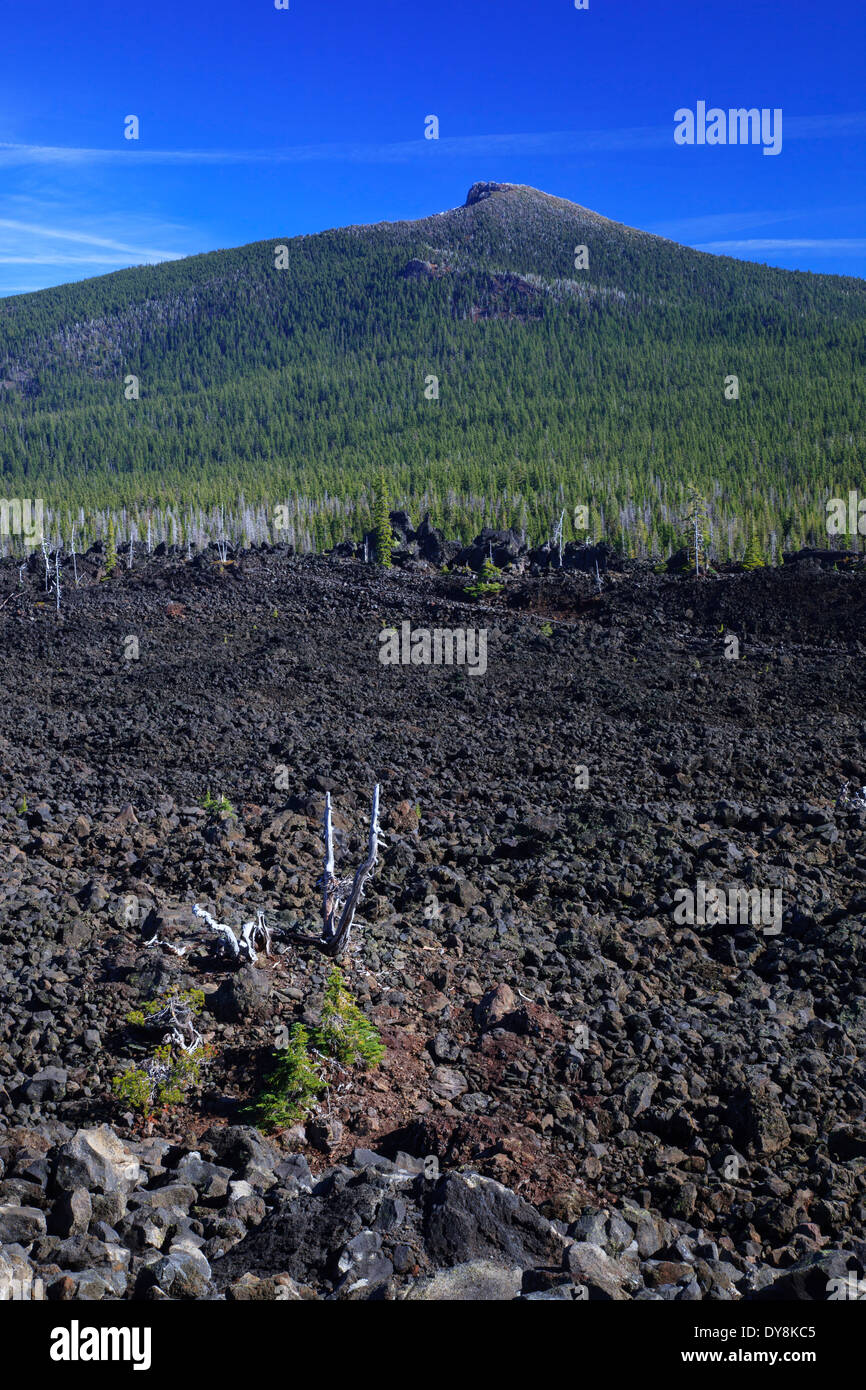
[0,182,866,555]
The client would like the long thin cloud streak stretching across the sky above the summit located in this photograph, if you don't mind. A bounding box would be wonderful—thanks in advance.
[0,108,866,168]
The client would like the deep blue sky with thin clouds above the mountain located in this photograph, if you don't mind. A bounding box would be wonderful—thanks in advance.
[0,0,866,295]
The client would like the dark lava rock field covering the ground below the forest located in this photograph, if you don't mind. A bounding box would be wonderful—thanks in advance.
[0,539,866,1301]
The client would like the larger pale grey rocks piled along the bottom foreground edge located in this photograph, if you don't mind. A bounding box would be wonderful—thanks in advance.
[0,1126,866,1301]
